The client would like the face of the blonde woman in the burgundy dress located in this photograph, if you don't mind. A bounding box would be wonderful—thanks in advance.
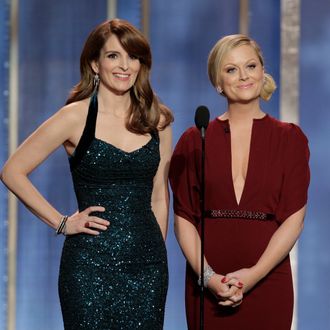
[219,45,264,102]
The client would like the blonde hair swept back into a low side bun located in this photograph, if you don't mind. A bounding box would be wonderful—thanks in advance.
[207,34,276,101]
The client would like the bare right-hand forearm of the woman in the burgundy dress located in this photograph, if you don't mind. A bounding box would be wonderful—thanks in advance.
[228,206,306,292]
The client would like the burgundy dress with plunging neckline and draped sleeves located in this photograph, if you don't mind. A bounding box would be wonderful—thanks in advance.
[170,115,309,330]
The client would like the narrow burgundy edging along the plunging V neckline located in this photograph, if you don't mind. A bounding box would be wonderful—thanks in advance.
[217,114,268,208]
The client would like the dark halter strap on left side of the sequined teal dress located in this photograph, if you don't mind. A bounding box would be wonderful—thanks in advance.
[70,90,98,170]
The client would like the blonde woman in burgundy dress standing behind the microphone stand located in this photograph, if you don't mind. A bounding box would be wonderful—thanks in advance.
[170,35,309,330]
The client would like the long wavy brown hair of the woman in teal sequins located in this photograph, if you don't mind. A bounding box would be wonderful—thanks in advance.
[66,19,173,134]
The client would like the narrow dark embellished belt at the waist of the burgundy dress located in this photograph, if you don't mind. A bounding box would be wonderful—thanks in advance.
[205,210,275,220]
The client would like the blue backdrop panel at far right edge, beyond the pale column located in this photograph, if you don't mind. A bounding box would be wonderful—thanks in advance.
[298,0,330,330]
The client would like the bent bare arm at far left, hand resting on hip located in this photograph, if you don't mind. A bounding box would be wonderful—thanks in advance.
[1,106,110,234]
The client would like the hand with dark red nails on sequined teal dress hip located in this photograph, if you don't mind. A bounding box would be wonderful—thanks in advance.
[64,206,110,236]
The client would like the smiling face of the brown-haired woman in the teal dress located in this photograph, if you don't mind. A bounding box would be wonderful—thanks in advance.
[92,34,141,95]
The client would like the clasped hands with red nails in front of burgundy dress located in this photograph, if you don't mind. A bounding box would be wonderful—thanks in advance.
[207,274,243,307]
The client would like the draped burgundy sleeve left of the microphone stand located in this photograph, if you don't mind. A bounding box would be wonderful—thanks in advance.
[169,128,201,226]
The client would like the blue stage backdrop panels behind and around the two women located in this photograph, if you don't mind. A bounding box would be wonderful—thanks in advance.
[0,0,330,330]
